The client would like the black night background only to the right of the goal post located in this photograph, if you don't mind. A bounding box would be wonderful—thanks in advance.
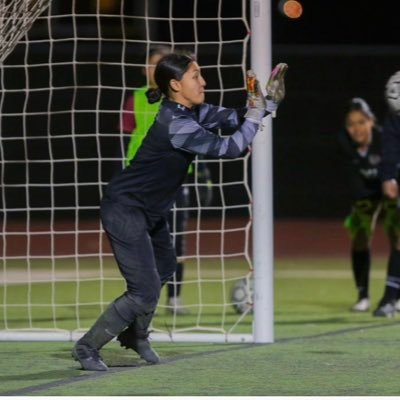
[272,0,400,218]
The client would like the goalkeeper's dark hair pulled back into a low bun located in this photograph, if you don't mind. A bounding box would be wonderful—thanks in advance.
[146,53,194,104]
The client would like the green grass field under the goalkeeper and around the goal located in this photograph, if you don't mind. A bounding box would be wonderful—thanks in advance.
[0,258,400,396]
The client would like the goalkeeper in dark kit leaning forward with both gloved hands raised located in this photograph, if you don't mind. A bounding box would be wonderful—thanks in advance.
[72,53,287,371]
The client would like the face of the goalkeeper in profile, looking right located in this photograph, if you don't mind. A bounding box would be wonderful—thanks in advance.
[170,61,206,108]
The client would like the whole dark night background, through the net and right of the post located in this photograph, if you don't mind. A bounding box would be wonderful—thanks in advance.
[0,0,400,218]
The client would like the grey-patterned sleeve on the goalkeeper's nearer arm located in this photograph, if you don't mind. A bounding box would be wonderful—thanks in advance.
[168,115,258,158]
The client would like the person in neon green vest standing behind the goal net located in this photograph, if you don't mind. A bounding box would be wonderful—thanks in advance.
[121,46,212,315]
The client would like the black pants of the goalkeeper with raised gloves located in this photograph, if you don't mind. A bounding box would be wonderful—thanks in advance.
[101,198,176,314]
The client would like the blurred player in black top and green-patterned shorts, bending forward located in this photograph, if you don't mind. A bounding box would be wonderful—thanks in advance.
[339,98,400,316]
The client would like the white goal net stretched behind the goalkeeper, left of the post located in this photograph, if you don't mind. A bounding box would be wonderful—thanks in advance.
[0,0,260,341]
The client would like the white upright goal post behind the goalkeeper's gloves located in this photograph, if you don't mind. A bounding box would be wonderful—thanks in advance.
[251,0,274,343]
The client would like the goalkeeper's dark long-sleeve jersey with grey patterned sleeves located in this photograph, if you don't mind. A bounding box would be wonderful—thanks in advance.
[106,99,258,216]
